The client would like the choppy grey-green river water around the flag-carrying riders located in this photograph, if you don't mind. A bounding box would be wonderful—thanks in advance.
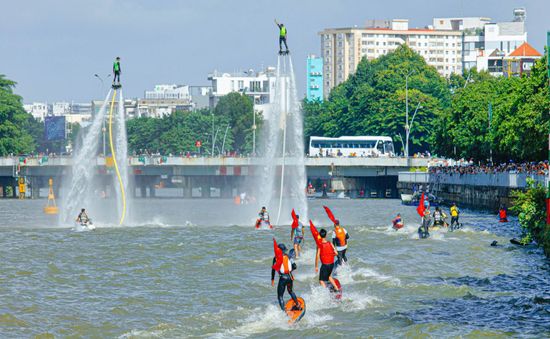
[0,199,550,338]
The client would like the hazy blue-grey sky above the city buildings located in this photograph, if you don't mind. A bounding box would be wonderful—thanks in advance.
[0,0,550,103]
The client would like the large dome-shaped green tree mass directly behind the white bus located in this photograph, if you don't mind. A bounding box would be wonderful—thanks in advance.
[303,45,451,154]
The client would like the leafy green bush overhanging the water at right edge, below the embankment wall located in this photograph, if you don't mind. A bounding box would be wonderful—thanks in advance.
[511,178,550,255]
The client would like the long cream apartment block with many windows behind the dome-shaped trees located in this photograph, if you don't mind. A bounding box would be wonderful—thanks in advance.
[319,19,462,97]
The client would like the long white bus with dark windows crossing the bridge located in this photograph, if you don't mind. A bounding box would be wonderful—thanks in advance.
[309,136,395,157]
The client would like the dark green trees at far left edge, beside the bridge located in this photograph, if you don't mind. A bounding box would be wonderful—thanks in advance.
[0,74,35,156]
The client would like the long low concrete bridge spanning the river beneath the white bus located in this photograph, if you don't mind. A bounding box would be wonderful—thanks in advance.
[0,156,429,198]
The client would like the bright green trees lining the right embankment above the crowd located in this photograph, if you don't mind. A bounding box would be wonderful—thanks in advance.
[434,57,550,161]
